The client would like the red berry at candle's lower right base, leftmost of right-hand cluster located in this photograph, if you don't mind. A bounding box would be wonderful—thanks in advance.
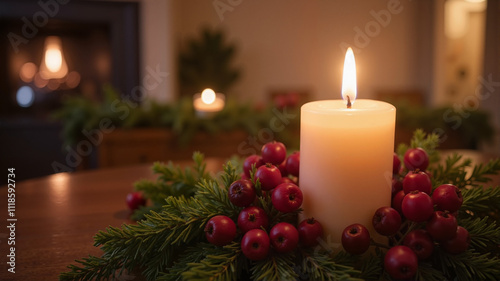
[342,223,370,255]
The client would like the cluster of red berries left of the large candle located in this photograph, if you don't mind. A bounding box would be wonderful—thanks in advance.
[204,141,323,260]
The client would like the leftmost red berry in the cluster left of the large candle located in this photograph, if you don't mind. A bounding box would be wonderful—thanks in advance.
[205,216,236,246]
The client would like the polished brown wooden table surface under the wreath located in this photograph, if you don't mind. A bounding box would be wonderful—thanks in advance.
[0,151,500,281]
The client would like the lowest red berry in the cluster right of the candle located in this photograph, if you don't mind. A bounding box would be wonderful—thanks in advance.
[384,246,418,280]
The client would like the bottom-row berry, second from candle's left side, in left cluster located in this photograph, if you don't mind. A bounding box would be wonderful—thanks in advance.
[269,222,299,253]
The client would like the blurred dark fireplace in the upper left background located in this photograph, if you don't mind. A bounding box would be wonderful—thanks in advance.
[0,0,139,178]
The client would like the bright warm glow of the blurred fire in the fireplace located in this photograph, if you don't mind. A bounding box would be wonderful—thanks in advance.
[40,36,68,79]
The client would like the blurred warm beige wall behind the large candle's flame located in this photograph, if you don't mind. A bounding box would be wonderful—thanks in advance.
[143,0,432,101]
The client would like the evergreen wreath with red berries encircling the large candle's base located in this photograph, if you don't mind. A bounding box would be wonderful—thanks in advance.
[60,130,500,281]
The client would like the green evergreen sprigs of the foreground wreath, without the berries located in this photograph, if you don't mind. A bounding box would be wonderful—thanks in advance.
[60,131,500,281]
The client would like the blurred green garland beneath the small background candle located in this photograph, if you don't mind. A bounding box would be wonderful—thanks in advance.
[52,86,299,148]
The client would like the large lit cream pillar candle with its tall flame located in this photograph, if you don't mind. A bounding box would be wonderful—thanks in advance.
[299,48,396,246]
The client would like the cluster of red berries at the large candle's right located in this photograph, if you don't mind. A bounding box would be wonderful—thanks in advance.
[342,148,470,279]
